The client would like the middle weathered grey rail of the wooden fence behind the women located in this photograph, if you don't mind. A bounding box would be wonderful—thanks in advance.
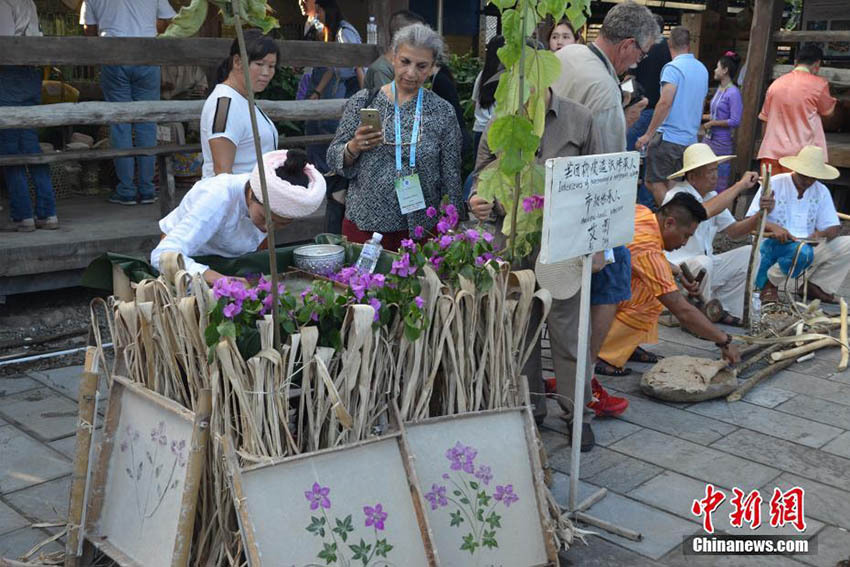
[0,98,346,128]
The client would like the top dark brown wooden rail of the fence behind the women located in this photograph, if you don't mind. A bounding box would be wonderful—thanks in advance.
[0,36,380,67]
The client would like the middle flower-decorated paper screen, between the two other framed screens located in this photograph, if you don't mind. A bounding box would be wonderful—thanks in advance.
[230,436,428,567]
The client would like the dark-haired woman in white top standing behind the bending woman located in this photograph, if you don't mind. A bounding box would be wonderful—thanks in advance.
[201,30,280,177]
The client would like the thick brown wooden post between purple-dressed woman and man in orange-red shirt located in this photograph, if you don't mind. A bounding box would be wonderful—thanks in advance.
[735,0,785,175]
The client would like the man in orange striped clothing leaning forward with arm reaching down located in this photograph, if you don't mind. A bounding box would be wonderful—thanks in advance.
[599,193,741,374]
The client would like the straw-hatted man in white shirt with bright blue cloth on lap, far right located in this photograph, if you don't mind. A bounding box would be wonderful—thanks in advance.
[747,146,850,303]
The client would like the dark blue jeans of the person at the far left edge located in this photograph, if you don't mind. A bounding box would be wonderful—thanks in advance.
[0,66,56,222]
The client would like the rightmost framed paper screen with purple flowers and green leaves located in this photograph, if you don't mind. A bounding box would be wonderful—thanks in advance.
[406,410,549,567]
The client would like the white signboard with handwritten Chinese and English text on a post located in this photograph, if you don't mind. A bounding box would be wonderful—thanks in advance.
[539,152,640,264]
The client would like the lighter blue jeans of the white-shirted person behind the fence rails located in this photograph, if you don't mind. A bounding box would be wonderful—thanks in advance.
[100,65,160,200]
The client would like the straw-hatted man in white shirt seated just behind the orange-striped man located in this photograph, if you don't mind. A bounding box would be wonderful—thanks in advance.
[664,144,773,326]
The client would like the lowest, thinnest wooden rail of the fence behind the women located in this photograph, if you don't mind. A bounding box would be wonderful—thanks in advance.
[0,134,334,167]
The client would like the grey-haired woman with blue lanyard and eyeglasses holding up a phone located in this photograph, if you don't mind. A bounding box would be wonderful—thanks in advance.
[327,24,463,250]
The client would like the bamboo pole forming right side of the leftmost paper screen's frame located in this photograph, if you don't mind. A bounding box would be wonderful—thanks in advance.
[171,389,212,567]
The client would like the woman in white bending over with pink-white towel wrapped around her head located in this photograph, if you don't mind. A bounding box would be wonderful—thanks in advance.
[151,150,325,285]
